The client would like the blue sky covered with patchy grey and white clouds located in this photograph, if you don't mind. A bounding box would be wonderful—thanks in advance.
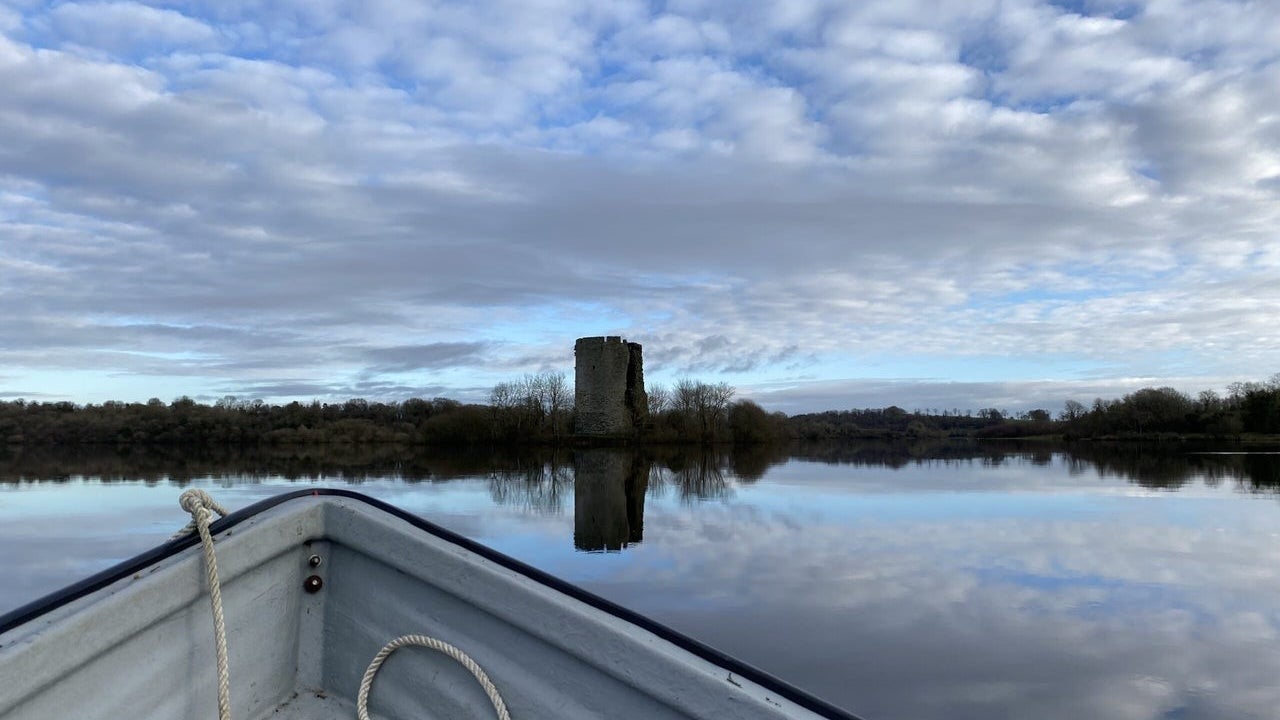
[0,0,1280,414]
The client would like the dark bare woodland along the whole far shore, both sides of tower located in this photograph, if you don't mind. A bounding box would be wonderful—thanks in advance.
[0,373,1280,446]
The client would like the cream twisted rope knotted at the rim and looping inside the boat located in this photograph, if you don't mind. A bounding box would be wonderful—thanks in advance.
[173,489,511,720]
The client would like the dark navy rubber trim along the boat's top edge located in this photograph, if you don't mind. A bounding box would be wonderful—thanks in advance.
[0,488,860,720]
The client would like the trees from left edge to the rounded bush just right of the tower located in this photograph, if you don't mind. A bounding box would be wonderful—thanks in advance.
[0,373,787,446]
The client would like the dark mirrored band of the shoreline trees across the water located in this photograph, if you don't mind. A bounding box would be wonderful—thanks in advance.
[0,439,1280,491]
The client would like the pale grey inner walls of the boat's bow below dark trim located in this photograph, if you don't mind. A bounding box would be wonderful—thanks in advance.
[0,491,851,720]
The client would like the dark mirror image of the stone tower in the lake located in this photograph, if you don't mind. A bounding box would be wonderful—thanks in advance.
[573,450,649,552]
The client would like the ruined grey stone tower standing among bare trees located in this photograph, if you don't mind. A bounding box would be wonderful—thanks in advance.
[573,336,649,436]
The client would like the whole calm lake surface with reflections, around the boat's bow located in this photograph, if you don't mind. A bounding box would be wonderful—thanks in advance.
[0,445,1280,720]
